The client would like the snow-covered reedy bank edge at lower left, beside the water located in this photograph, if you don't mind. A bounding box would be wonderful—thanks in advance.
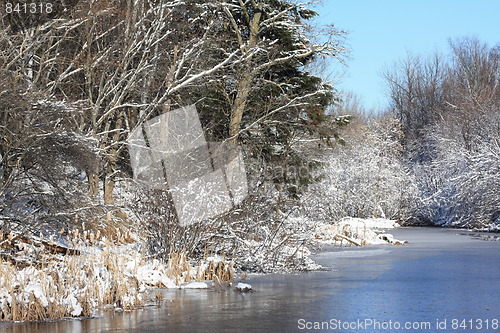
[0,243,233,321]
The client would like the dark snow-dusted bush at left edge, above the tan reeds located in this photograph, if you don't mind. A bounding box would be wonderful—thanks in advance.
[0,76,97,236]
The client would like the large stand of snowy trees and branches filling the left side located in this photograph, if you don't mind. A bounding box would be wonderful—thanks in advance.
[0,0,345,268]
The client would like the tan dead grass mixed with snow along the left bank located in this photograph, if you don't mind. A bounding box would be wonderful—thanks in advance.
[0,218,238,321]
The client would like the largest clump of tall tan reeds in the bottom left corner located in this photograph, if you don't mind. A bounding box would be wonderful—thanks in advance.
[0,241,146,321]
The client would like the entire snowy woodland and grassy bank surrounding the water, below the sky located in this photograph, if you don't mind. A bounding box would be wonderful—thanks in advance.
[0,0,500,320]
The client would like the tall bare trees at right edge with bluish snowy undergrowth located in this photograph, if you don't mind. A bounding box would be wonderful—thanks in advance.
[385,38,500,228]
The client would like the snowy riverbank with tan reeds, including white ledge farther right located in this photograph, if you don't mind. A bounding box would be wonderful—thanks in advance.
[0,218,404,321]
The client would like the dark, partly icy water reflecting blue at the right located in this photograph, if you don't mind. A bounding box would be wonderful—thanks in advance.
[0,228,500,333]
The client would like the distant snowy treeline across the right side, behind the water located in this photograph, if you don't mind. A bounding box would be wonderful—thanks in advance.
[312,37,500,230]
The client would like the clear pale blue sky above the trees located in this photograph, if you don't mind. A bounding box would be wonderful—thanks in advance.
[315,0,500,109]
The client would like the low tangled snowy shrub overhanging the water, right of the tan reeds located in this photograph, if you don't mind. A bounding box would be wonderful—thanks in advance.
[128,161,313,272]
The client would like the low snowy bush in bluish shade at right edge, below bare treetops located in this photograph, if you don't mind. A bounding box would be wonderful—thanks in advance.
[413,110,500,229]
